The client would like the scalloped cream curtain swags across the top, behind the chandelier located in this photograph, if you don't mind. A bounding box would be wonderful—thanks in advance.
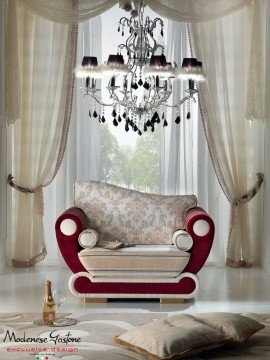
[15,0,252,23]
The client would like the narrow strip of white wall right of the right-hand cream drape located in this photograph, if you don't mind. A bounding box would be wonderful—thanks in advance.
[262,1,270,274]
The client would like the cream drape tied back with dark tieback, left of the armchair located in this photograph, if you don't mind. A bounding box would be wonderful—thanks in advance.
[6,1,77,267]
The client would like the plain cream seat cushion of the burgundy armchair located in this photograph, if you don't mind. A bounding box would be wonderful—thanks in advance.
[79,245,190,282]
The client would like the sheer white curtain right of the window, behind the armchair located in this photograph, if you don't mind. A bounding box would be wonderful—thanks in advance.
[161,21,230,266]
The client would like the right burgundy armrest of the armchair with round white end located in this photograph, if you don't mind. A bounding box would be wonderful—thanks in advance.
[183,207,215,274]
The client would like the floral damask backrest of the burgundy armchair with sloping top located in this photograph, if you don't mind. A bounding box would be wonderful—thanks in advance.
[74,181,197,245]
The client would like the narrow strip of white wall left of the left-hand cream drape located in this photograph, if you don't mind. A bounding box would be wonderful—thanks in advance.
[0,1,7,274]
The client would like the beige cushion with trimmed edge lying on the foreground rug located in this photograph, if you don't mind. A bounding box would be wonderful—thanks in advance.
[114,313,264,360]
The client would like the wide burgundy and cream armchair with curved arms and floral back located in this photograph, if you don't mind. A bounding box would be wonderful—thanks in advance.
[55,181,215,299]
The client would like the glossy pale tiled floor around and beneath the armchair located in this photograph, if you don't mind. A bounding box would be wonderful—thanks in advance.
[0,266,270,313]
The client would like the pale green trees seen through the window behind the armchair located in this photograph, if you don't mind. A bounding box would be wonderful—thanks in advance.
[99,124,160,193]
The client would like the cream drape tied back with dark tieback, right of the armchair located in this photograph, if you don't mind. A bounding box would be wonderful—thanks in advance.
[190,2,263,267]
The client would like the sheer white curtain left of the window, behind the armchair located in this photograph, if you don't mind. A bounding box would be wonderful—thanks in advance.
[43,16,102,265]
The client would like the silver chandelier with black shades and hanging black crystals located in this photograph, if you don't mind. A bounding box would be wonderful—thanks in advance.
[75,1,205,135]
